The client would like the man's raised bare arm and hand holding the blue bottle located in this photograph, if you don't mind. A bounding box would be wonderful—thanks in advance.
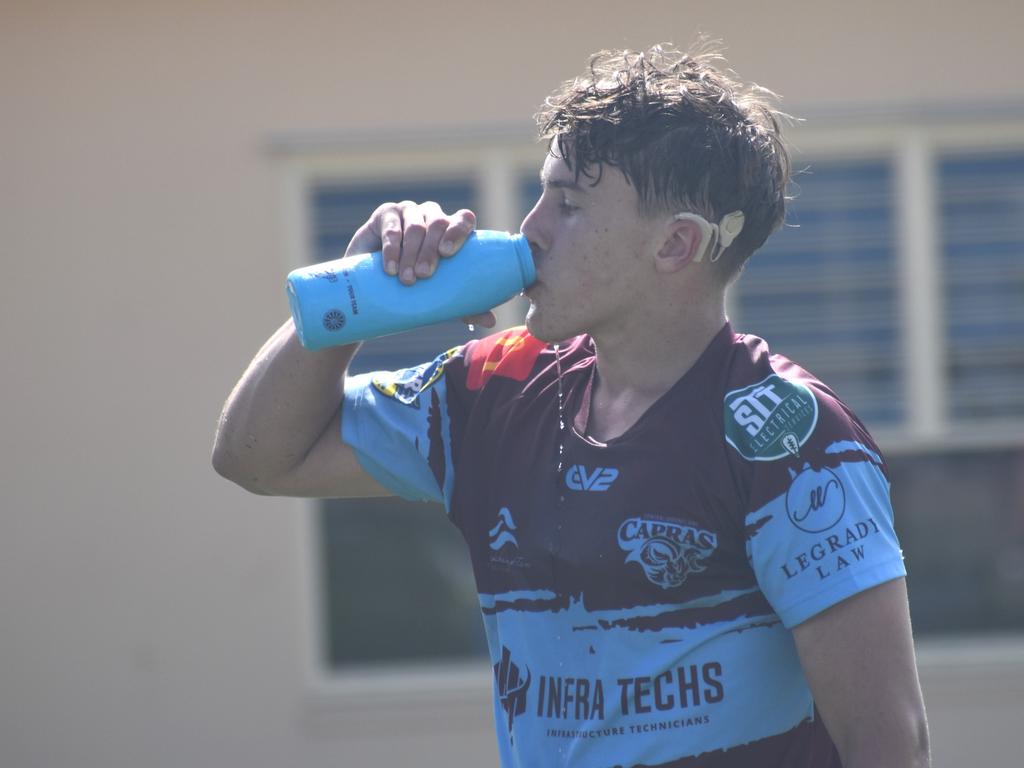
[213,202,483,498]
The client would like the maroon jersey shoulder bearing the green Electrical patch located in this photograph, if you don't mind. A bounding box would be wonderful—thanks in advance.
[723,334,881,463]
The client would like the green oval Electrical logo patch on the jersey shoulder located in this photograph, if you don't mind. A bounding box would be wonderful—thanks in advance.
[725,374,818,462]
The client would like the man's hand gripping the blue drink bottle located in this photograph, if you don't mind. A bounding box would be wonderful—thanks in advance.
[345,200,497,328]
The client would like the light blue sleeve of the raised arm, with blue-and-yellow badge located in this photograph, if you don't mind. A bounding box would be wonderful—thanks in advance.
[341,349,457,508]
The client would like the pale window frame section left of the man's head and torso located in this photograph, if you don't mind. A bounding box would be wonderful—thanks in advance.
[270,131,544,704]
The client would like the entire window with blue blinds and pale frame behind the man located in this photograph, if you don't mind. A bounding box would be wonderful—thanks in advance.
[278,124,1024,672]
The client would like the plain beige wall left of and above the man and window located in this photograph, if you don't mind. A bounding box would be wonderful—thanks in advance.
[0,0,1024,768]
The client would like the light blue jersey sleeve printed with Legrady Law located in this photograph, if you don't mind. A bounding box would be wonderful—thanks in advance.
[746,440,906,628]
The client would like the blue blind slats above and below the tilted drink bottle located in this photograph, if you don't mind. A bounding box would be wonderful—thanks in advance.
[308,179,476,373]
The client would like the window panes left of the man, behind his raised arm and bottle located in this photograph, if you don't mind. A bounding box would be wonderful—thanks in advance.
[308,180,486,670]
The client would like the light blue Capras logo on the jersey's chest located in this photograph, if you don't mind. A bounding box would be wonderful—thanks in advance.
[618,517,718,589]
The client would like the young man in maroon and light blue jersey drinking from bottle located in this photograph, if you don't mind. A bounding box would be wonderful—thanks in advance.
[214,48,929,768]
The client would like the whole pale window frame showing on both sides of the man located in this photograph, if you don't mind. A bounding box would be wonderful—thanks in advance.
[268,116,1024,708]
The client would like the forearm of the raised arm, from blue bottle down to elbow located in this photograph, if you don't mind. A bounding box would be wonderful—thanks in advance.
[213,319,358,493]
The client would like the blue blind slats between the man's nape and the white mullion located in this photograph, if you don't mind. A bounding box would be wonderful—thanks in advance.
[735,160,905,426]
